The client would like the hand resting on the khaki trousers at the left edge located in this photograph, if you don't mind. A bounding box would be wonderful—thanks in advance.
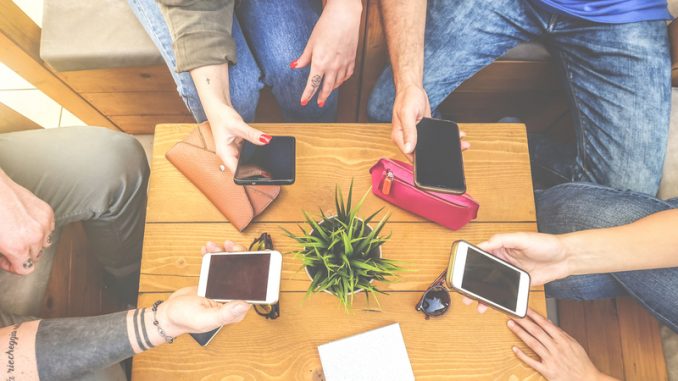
[0,171,55,275]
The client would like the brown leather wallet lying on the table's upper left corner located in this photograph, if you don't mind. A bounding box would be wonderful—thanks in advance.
[165,122,280,231]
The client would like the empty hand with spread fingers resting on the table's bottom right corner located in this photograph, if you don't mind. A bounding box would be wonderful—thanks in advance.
[507,309,608,381]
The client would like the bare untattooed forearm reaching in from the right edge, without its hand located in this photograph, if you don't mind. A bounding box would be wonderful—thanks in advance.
[562,209,678,274]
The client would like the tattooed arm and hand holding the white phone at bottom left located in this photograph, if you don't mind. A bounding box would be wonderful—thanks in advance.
[0,241,250,381]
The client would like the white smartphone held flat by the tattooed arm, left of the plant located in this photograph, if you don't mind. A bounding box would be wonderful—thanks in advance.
[198,251,282,304]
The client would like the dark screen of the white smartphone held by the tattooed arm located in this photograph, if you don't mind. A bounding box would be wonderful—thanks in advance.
[205,254,271,300]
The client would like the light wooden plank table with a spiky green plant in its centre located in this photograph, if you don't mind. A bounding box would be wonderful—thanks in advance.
[133,124,546,381]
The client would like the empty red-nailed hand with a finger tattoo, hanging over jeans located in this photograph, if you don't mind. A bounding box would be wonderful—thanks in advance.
[290,0,362,107]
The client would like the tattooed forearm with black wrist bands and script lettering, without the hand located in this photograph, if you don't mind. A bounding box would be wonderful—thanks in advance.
[0,309,176,380]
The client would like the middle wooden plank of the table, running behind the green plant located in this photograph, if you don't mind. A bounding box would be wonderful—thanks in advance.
[139,223,541,292]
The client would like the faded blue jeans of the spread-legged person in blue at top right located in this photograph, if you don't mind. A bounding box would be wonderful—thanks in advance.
[368,0,671,195]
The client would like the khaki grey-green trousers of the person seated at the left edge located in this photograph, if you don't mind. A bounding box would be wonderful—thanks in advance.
[0,127,149,316]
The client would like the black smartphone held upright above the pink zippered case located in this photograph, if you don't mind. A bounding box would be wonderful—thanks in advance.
[414,118,466,194]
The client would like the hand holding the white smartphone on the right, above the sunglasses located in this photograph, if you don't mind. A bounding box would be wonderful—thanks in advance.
[463,233,572,313]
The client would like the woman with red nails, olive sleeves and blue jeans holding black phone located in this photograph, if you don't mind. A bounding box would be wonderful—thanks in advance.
[129,0,362,171]
